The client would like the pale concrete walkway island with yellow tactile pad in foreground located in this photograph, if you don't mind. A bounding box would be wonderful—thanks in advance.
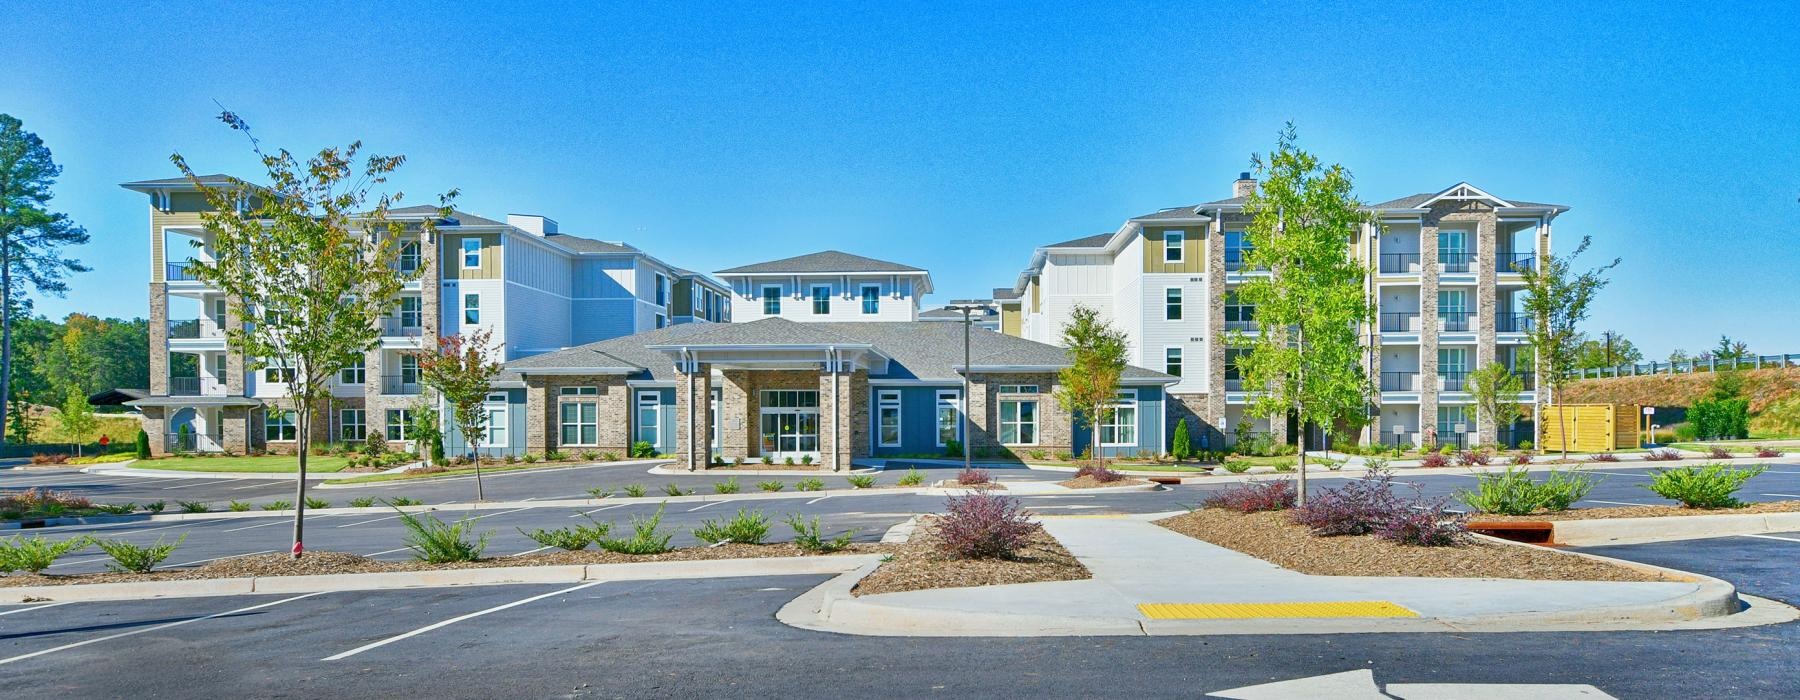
[783,513,1793,635]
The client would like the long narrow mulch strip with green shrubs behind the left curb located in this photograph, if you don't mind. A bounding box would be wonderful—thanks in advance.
[0,542,893,587]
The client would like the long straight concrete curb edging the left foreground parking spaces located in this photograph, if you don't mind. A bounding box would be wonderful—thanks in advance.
[0,554,880,603]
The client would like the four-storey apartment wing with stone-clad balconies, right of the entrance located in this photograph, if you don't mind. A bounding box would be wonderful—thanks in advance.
[994,173,1568,444]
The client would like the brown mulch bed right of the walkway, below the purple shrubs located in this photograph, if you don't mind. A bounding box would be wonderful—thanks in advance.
[1156,507,1665,581]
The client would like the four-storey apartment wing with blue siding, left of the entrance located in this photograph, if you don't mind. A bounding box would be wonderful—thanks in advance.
[122,175,731,453]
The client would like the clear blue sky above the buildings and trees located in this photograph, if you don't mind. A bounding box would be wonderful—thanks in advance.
[0,2,1800,358]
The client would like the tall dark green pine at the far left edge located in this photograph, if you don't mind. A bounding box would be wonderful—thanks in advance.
[0,113,88,442]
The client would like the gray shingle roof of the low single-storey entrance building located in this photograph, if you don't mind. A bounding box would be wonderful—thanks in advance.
[506,319,1172,381]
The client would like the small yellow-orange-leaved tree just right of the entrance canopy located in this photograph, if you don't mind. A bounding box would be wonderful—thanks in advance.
[1055,304,1127,464]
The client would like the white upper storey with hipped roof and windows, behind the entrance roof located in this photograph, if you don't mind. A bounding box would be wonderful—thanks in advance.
[716,250,931,322]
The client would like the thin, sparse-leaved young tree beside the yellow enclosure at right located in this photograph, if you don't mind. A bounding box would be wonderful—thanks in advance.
[1521,236,1618,459]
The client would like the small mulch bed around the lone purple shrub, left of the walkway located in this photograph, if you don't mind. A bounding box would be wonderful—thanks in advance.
[851,518,1094,596]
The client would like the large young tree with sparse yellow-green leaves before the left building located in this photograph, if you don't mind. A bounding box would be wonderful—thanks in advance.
[171,112,455,558]
